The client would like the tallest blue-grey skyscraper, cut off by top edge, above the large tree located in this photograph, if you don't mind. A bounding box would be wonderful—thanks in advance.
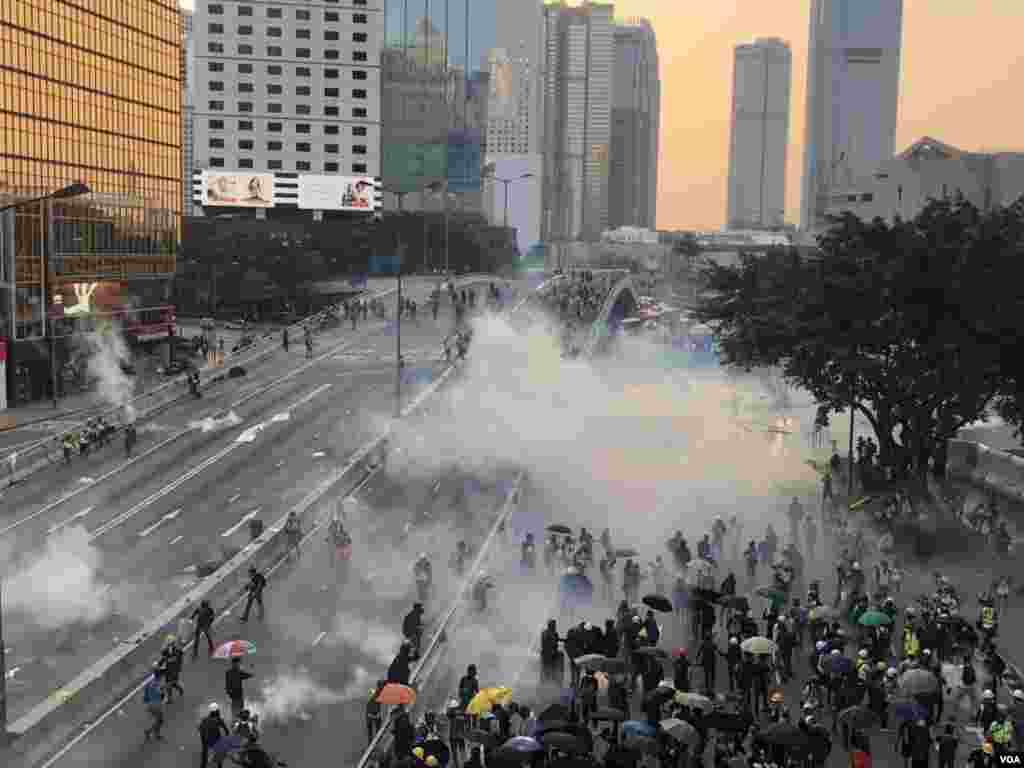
[801,0,903,231]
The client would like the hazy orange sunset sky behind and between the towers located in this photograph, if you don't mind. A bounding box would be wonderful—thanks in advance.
[615,0,1024,229]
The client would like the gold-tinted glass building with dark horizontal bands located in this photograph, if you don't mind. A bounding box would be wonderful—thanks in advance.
[0,0,182,400]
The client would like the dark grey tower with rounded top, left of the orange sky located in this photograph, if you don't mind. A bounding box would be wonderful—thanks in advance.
[608,18,662,229]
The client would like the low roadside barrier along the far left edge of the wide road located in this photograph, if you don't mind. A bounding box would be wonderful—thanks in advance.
[0,273,499,483]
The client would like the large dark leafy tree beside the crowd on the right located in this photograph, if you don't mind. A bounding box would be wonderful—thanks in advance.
[696,198,1024,477]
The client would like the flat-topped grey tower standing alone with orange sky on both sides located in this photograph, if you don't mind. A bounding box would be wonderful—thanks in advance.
[726,38,793,229]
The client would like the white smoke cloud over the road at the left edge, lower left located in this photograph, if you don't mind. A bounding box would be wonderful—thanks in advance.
[4,526,113,630]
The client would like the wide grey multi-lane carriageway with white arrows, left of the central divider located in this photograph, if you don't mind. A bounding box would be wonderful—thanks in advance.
[0,282,520,719]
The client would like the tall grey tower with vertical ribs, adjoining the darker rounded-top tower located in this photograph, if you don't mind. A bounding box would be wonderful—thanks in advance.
[541,1,614,242]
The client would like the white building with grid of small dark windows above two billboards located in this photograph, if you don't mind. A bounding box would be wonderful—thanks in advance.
[194,0,384,215]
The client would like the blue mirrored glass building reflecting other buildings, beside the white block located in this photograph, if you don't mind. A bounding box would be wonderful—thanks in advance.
[381,0,501,208]
